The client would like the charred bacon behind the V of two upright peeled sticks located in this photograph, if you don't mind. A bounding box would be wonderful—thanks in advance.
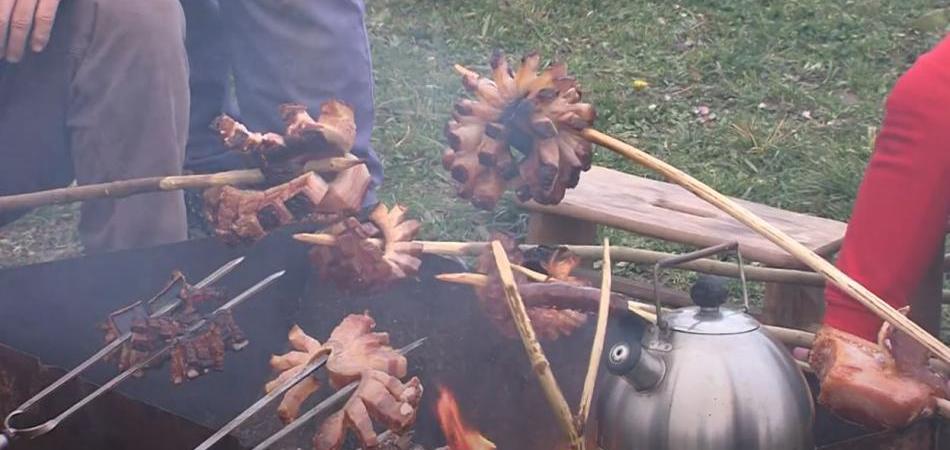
[475,233,596,341]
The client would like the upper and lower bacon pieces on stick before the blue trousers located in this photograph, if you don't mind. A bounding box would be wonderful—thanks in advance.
[204,100,371,243]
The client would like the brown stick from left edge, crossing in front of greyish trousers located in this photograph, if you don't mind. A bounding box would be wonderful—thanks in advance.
[0,157,364,212]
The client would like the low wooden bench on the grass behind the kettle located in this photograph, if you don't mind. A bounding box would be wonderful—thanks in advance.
[523,167,847,328]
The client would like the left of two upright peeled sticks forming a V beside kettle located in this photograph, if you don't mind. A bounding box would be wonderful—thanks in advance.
[491,241,584,450]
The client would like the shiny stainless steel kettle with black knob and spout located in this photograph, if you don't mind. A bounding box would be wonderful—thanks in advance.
[597,243,814,450]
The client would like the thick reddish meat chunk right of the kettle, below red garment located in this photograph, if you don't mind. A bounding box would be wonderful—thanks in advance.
[809,327,937,430]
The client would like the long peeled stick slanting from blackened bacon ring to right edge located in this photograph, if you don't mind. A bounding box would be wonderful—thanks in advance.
[580,128,950,362]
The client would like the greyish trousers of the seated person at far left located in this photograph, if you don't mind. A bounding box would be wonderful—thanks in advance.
[0,0,189,253]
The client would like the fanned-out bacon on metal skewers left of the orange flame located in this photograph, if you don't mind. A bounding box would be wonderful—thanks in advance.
[265,314,422,450]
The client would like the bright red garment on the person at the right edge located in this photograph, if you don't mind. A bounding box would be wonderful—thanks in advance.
[825,36,950,341]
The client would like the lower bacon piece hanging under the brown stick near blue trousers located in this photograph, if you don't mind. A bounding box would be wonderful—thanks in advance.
[204,173,327,243]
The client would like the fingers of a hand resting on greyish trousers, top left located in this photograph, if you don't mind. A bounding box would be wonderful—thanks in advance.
[0,0,59,63]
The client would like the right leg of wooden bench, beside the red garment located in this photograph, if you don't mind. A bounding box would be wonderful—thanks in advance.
[762,283,825,331]
